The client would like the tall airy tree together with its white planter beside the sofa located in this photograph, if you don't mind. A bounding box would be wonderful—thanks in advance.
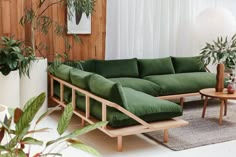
[20,0,95,111]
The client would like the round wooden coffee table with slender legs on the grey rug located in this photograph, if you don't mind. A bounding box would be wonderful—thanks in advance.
[199,88,236,125]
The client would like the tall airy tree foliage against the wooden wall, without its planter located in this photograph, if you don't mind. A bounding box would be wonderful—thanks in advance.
[20,0,95,54]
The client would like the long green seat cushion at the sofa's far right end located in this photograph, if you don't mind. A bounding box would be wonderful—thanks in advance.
[144,72,216,95]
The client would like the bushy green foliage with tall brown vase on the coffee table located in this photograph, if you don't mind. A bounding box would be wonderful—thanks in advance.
[200,34,236,92]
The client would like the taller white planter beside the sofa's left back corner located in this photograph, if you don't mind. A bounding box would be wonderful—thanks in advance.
[20,58,48,116]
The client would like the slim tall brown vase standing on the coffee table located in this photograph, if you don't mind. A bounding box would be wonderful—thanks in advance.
[215,64,225,92]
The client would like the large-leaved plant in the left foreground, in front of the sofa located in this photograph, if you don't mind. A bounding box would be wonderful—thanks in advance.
[0,93,107,157]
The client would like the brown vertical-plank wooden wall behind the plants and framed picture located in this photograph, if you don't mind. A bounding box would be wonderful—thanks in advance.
[0,0,106,61]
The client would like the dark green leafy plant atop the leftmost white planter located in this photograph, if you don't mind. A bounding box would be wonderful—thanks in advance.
[0,36,35,76]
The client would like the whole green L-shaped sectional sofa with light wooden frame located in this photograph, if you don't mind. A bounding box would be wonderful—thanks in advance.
[51,56,216,151]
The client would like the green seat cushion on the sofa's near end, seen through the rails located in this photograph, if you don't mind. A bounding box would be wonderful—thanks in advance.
[76,87,182,128]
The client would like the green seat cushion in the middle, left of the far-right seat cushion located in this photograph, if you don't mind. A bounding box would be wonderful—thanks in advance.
[110,77,161,96]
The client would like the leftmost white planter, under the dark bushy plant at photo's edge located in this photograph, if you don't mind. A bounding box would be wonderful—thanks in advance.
[0,70,20,108]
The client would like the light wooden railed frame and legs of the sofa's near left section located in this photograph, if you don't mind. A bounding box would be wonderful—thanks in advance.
[49,74,188,151]
